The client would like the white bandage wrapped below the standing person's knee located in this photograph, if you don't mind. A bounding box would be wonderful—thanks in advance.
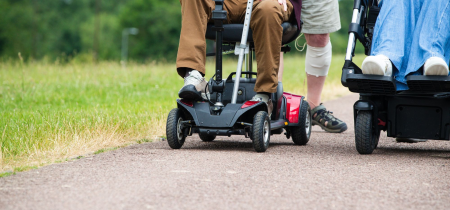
[305,42,331,77]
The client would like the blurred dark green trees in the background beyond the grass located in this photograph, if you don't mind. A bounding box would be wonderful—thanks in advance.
[0,0,363,62]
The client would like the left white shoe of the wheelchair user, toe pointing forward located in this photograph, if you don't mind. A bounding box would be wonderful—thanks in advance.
[361,55,392,76]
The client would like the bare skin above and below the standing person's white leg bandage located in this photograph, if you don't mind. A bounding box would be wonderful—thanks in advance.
[305,34,330,109]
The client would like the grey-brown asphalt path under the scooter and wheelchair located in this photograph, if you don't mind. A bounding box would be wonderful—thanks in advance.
[0,94,450,210]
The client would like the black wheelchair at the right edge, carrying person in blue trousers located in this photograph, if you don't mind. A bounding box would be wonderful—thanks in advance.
[341,0,450,154]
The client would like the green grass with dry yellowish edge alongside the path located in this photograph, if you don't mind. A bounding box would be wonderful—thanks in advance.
[0,55,360,171]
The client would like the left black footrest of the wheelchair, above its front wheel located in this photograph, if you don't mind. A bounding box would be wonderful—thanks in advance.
[347,74,397,95]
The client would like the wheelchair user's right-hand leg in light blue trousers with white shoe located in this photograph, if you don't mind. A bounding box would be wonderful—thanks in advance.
[405,0,450,76]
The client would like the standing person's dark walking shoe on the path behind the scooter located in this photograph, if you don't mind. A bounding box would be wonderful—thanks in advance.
[311,104,347,133]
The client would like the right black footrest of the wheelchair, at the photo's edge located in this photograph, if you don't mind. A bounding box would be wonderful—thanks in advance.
[406,75,450,92]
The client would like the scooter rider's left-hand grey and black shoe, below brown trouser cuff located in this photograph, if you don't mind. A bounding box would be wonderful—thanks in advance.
[178,70,209,101]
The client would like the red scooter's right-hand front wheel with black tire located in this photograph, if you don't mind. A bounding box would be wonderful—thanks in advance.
[252,111,270,152]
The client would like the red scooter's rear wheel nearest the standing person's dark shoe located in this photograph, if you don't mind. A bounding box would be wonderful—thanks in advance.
[290,100,312,145]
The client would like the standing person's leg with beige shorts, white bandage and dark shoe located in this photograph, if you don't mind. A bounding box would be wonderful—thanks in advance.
[302,0,347,133]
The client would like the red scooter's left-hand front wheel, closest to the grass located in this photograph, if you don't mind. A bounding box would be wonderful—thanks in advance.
[166,108,186,149]
